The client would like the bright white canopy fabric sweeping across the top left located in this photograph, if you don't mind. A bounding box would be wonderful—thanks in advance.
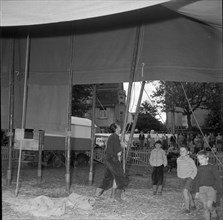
[0,0,168,26]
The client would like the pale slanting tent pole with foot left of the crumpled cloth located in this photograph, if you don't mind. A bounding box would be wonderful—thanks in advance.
[15,34,30,196]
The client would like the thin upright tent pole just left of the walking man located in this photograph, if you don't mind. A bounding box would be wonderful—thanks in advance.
[89,85,96,184]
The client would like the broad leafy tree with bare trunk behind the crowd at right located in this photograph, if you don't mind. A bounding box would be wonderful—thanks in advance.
[152,81,218,130]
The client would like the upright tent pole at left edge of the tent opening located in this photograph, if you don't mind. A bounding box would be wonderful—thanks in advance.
[65,35,74,193]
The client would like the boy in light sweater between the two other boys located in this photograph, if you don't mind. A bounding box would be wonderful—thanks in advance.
[177,146,197,214]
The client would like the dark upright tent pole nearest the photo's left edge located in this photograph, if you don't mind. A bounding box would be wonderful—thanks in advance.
[7,39,15,186]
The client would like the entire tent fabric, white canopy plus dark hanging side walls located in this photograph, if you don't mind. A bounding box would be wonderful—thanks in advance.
[0,0,223,131]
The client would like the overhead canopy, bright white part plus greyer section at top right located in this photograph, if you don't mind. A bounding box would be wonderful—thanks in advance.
[0,0,222,28]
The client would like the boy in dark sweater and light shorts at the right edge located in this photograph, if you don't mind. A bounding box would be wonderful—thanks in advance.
[195,150,221,220]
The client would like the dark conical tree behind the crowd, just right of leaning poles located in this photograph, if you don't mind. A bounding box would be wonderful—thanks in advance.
[136,100,163,132]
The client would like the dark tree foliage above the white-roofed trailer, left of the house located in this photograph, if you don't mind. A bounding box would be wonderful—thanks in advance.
[72,85,92,117]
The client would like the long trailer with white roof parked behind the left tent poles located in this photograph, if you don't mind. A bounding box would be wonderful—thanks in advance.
[14,116,91,167]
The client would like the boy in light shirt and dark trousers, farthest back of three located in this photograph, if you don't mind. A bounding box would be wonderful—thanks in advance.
[149,140,167,195]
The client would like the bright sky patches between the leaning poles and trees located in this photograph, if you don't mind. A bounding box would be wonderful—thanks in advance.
[124,81,166,122]
